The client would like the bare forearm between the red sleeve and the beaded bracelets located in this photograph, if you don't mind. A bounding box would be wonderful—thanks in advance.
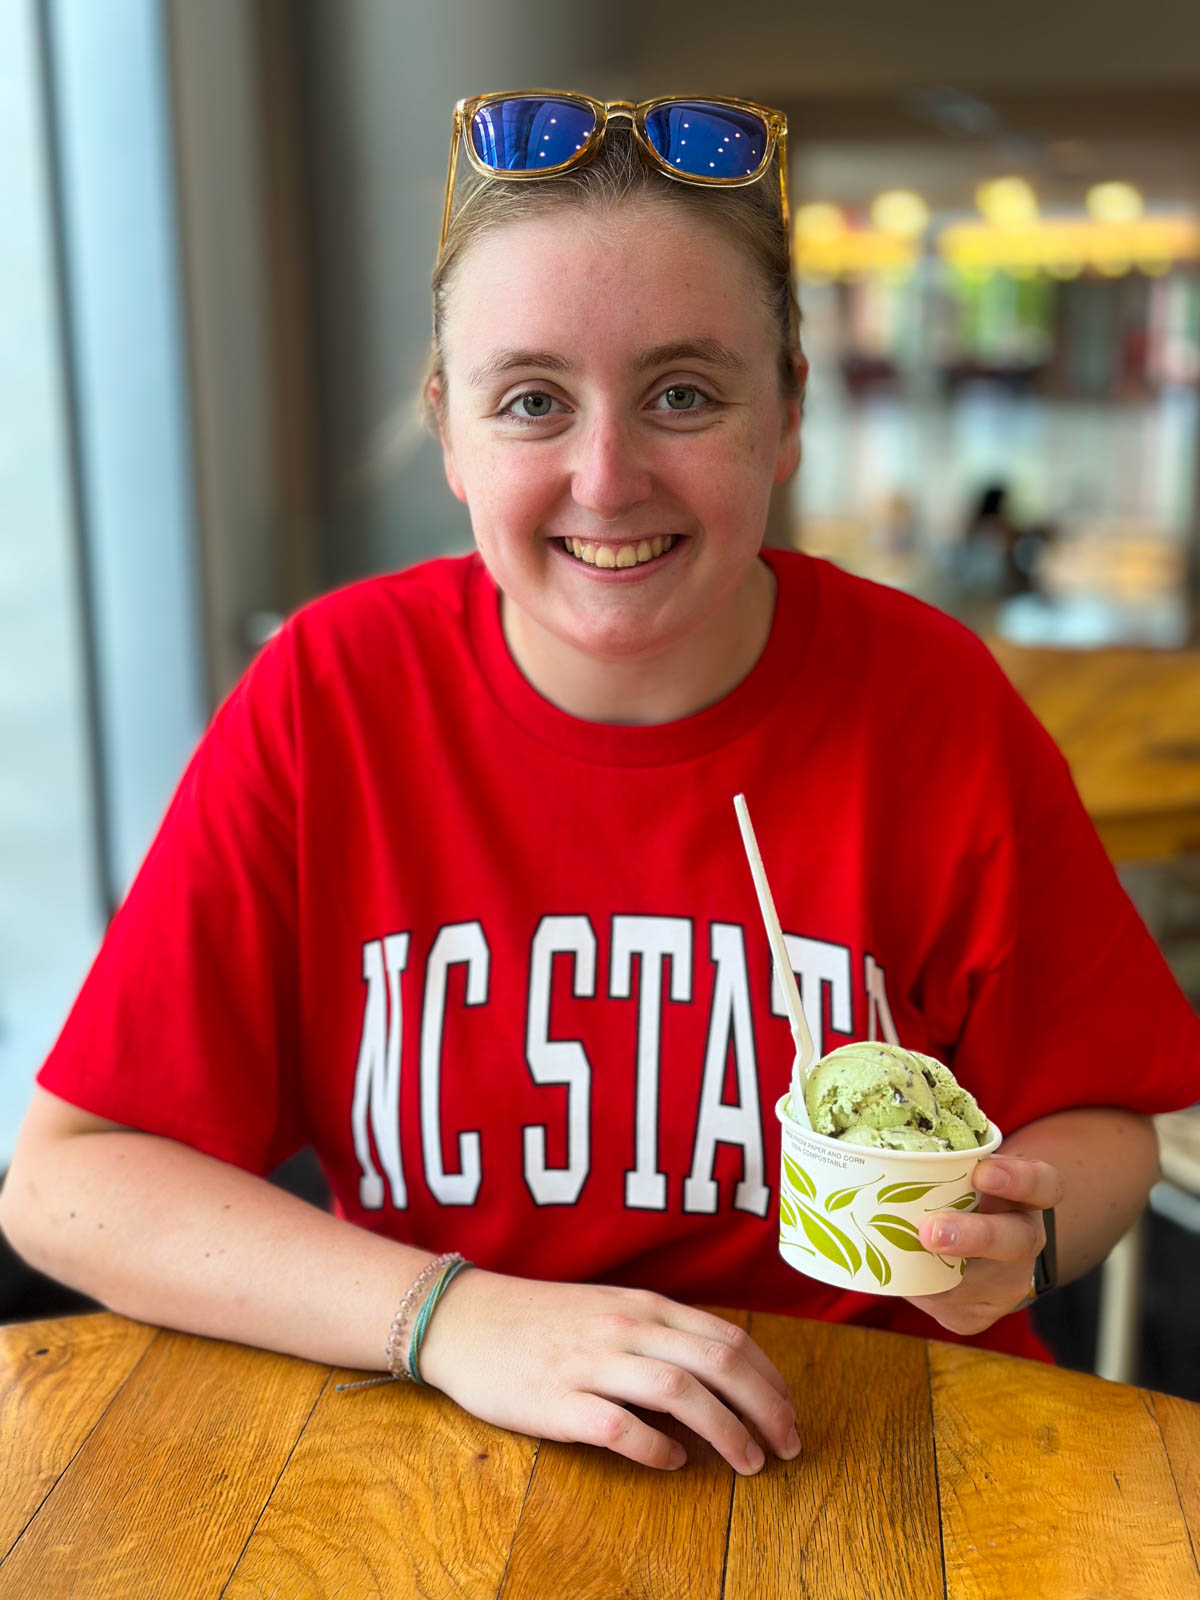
[3,1133,429,1370]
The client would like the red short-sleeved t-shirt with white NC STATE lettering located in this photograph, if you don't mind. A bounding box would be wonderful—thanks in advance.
[40,552,1200,1354]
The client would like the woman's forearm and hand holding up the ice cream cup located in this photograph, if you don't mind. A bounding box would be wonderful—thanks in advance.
[912,1107,1158,1334]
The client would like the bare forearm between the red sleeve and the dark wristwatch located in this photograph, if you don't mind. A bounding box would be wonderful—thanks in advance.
[998,1107,1158,1283]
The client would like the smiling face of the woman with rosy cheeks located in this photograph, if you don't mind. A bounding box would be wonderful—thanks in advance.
[443,203,798,675]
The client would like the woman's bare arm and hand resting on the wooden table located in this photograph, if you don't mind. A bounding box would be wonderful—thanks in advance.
[0,1090,800,1472]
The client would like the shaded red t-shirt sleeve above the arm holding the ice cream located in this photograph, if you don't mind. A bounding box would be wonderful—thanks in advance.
[952,681,1200,1133]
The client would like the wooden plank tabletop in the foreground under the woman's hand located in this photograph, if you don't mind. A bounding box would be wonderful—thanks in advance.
[0,1314,1200,1600]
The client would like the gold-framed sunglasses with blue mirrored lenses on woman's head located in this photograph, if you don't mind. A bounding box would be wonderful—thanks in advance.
[438,90,789,254]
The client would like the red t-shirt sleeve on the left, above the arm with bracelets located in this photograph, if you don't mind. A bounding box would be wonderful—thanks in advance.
[38,630,304,1173]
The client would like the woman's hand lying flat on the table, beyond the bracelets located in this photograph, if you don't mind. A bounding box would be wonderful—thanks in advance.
[421,1269,800,1474]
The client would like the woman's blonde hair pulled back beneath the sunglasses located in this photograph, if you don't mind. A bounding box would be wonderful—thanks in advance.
[421,126,800,432]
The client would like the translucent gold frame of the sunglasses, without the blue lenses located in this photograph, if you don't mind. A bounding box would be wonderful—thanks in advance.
[437,90,792,259]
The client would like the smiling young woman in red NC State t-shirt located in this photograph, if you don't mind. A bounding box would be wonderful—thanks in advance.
[3,96,1200,1472]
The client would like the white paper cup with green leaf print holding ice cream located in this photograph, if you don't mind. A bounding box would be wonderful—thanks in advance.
[774,1094,1002,1294]
